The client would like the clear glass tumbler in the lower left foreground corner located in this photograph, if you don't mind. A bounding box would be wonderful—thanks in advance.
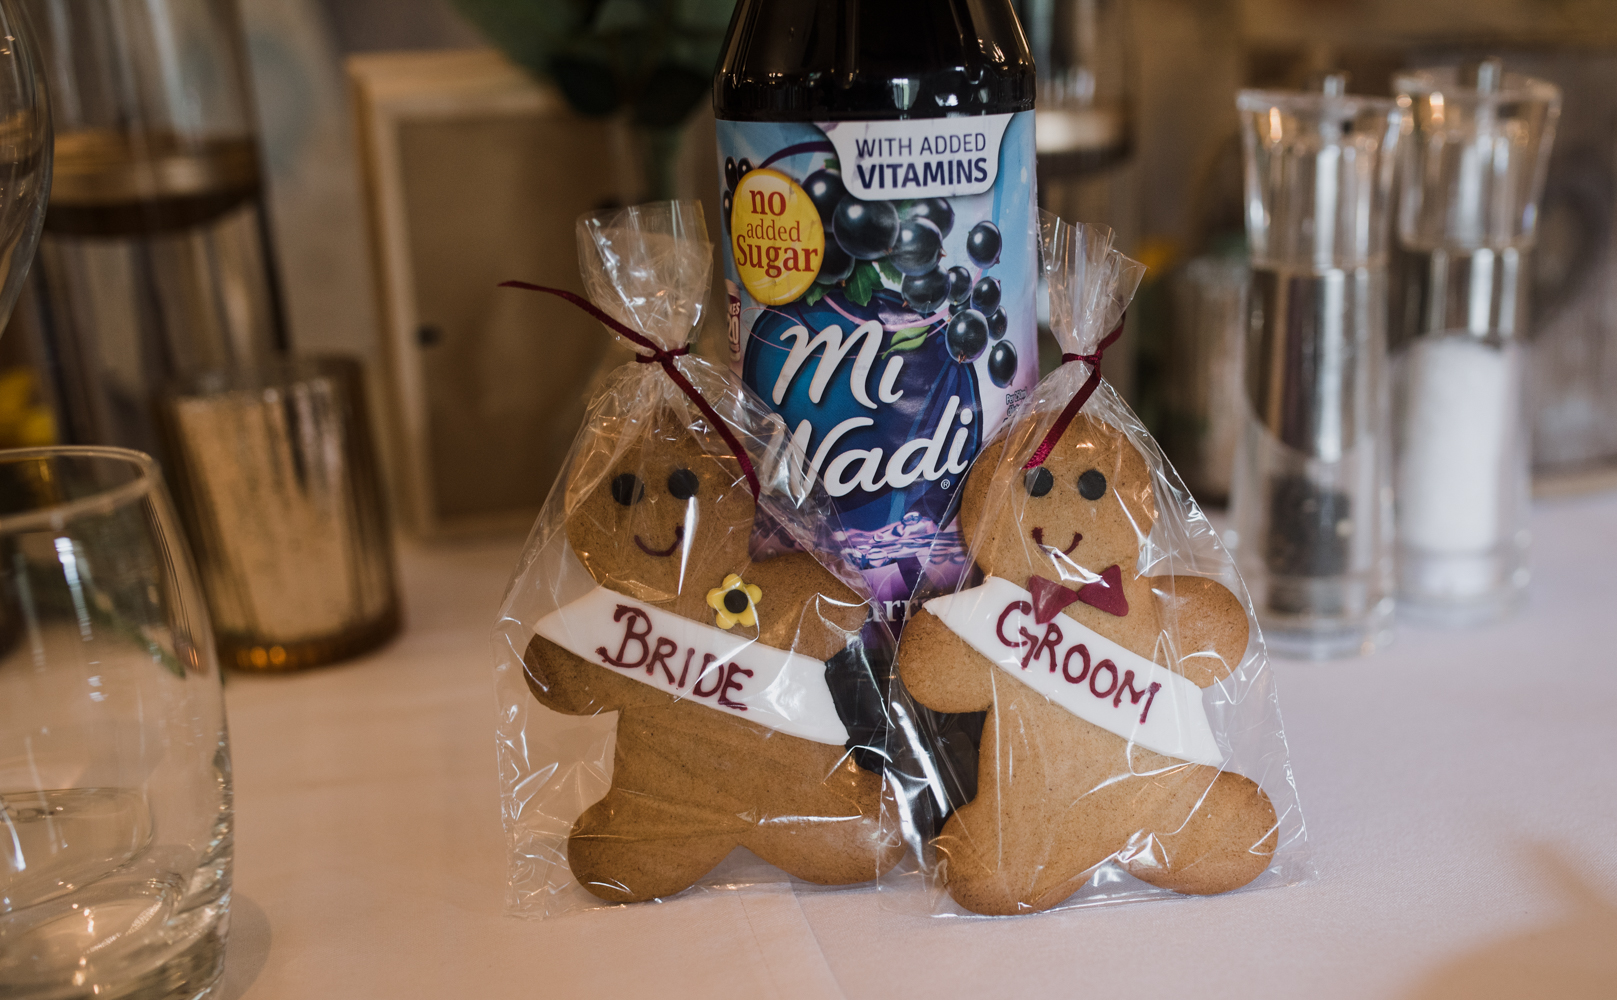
[0,448,231,1000]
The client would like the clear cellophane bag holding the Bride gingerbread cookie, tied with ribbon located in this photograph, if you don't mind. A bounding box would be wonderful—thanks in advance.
[495,202,904,916]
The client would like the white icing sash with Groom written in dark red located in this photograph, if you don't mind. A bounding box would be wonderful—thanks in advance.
[925,576,1224,767]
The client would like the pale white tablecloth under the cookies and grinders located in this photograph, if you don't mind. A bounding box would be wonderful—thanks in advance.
[222,494,1617,1000]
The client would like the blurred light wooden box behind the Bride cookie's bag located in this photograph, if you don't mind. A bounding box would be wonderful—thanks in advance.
[348,50,624,537]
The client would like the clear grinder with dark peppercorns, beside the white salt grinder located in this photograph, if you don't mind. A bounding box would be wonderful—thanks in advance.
[1231,76,1400,659]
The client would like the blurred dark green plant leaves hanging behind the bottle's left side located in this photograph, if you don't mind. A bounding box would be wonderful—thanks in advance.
[456,0,736,197]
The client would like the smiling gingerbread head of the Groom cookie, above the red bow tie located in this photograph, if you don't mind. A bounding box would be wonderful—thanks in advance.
[960,414,1156,587]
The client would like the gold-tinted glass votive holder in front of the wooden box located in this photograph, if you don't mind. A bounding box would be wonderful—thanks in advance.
[157,356,401,670]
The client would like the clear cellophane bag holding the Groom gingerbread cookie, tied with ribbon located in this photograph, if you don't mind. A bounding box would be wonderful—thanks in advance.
[881,214,1308,916]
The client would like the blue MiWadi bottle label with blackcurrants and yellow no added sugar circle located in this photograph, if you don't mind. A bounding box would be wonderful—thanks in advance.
[718,112,1038,626]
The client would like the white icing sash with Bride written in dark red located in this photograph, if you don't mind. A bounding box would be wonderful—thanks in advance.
[534,587,847,746]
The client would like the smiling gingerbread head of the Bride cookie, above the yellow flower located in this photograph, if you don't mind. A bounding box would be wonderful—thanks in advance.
[566,402,757,602]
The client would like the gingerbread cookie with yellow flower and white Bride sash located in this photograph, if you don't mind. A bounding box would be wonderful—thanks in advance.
[524,413,902,901]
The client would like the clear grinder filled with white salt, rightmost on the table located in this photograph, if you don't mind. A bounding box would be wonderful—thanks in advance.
[1392,60,1560,623]
